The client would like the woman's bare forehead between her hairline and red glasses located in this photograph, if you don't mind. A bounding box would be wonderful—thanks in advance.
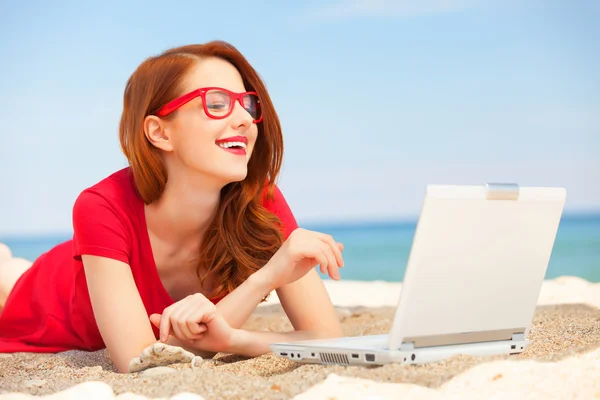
[184,58,245,92]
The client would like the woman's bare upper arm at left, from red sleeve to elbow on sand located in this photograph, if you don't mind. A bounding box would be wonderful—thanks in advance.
[82,255,162,373]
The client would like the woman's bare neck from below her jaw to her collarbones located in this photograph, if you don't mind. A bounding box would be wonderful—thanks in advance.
[146,170,222,247]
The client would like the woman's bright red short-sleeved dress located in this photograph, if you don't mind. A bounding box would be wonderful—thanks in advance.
[0,168,297,353]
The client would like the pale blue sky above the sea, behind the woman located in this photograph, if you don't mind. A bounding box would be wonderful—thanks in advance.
[0,0,600,235]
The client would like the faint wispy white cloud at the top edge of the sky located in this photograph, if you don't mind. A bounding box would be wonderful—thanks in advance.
[309,0,481,20]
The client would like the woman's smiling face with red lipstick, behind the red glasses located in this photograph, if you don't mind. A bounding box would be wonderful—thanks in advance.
[149,58,258,187]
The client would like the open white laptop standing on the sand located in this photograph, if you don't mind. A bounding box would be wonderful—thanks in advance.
[271,183,566,365]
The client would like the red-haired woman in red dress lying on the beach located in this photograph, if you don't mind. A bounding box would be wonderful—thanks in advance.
[0,42,343,372]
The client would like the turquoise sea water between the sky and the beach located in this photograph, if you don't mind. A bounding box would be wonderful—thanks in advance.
[0,214,600,282]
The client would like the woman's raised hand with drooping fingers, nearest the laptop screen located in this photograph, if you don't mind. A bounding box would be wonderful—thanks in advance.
[260,228,344,290]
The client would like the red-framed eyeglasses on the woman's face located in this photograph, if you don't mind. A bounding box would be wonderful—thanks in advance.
[156,87,263,124]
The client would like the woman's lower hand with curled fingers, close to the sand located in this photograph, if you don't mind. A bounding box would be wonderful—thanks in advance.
[150,293,235,352]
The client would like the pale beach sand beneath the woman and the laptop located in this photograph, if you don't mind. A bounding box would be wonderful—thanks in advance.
[0,277,600,400]
